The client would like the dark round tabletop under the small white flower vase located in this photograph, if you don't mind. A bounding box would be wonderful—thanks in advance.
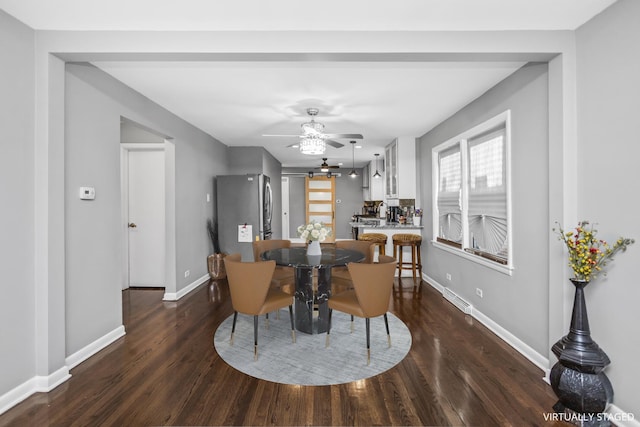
[262,246,365,267]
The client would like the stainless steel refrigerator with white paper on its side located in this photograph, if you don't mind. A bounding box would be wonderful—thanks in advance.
[216,174,273,261]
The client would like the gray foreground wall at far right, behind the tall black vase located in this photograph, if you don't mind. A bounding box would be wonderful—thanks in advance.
[576,0,640,414]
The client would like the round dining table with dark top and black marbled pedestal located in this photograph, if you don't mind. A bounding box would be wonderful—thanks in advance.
[261,246,365,334]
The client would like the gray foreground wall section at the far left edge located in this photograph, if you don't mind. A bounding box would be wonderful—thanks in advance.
[0,10,36,396]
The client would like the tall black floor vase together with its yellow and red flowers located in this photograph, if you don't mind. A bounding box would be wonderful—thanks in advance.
[549,221,635,425]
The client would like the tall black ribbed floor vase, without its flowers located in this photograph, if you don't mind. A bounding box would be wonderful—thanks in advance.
[550,279,613,426]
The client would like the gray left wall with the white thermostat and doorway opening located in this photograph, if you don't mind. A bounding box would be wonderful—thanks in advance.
[65,64,227,355]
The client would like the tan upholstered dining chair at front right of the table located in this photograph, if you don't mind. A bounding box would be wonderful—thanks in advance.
[326,255,396,365]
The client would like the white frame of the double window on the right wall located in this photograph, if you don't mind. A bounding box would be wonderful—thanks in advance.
[431,110,514,275]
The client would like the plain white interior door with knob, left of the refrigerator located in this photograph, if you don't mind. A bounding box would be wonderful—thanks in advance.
[128,150,165,287]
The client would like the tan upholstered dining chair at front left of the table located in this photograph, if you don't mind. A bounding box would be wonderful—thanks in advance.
[224,254,296,360]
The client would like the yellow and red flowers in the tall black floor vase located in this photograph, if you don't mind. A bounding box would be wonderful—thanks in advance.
[554,221,635,282]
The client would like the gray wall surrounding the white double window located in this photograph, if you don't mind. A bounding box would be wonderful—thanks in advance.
[419,64,551,355]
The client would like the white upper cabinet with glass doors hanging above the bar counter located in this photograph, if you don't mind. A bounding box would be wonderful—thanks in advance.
[385,137,417,199]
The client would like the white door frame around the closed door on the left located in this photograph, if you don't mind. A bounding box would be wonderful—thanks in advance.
[120,139,176,299]
